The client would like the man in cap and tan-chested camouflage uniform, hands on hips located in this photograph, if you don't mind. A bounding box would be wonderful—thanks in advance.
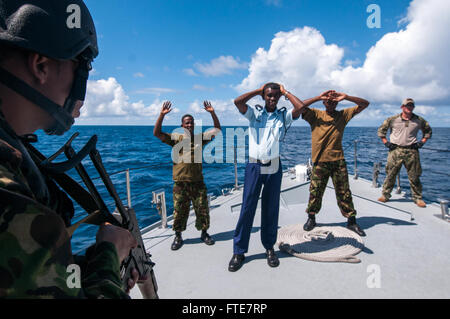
[378,98,432,207]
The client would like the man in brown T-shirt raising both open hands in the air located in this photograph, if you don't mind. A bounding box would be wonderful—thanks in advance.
[153,101,221,250]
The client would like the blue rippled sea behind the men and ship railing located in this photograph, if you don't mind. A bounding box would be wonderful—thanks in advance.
[35,126,450,252]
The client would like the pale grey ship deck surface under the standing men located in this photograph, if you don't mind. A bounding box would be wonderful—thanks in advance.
[131,174,450,299]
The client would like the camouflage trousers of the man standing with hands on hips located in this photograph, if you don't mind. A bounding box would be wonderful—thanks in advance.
[382,147,422,201]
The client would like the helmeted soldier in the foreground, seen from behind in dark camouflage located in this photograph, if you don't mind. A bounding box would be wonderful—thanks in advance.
[0,0,137,298]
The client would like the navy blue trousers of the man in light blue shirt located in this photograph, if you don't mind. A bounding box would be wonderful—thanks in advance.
[233,161,283,254]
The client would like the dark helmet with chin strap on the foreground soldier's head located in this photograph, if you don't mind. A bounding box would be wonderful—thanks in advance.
[0,0,98,135]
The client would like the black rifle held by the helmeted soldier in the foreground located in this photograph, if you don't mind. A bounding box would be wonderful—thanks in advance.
[27,132,158,299]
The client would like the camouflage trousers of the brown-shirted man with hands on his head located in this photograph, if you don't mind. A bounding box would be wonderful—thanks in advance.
[306,159,356,218]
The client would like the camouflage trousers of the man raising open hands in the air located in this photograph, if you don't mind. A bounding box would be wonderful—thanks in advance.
[173,182,209,232]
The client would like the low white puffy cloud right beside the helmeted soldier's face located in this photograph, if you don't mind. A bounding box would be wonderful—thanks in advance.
[80,77,179,119]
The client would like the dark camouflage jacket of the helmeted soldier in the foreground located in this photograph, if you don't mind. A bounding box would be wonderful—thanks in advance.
[0,113,128,298]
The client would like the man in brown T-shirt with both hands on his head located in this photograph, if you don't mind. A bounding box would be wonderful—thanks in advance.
[302,90,369,236]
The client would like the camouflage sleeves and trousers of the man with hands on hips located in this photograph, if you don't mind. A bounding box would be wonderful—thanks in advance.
[378,114,432,201]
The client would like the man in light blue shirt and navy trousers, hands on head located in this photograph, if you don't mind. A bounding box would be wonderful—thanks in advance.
[228,83,305,271]
